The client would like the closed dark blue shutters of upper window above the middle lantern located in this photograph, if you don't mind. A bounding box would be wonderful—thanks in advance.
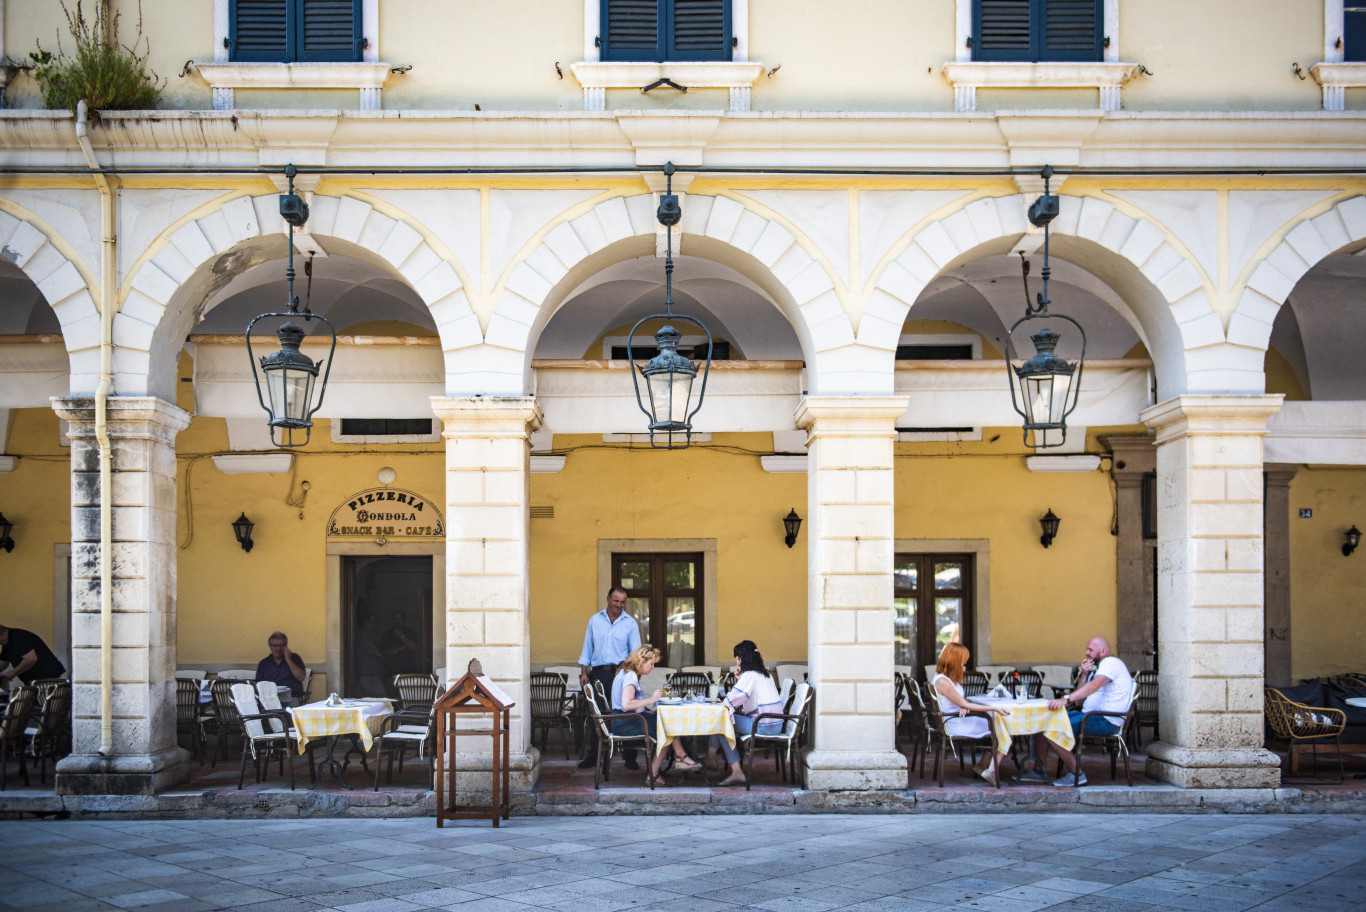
[598,0,734,61]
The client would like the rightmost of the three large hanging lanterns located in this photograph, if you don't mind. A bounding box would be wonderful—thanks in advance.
[1005,165,1086,449]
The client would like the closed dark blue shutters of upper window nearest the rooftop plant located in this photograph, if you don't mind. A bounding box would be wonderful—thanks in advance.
[228,0,365,63]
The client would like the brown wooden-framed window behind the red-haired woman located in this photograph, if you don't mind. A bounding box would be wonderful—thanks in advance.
[892,554,974,672]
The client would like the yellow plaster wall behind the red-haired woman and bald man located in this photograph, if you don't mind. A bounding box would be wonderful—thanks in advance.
[896,427,1116,662]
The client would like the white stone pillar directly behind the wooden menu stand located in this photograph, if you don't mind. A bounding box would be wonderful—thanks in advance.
[432,396,541,793]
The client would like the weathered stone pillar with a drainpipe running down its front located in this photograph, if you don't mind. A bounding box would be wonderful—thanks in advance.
[53,397,190,795]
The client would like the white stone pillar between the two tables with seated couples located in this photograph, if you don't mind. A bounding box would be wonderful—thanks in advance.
[796,396,907,790]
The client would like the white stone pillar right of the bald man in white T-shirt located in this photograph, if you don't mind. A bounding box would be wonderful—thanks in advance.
[1141,396,1281,788]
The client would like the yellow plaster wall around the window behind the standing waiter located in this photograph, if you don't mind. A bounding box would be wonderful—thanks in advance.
[531,434,806,664]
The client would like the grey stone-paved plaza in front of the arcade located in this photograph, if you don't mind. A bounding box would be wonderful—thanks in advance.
[0,814,1366,912]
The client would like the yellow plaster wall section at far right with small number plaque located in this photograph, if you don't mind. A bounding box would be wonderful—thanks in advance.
[1290,466,1366,681]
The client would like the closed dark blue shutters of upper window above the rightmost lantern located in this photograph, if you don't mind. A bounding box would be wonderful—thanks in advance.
[973,0,1104,61]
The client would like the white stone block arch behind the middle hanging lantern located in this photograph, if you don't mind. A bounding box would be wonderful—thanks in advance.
[482,194,852,395]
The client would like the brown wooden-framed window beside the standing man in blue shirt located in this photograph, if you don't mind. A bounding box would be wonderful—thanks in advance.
[612,552,706,668]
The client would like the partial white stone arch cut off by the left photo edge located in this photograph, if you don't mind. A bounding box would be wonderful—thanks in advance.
[0,201,100,396]
